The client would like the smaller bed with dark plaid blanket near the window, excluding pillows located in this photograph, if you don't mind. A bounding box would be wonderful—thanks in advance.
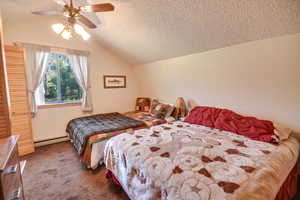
[66,111,167,169]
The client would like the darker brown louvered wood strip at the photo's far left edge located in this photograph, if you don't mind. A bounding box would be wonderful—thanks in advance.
[0,16,10,138]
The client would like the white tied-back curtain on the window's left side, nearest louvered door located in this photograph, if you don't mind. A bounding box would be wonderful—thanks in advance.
[24,45,50,116]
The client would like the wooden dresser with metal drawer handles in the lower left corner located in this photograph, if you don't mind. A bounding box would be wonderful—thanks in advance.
[0,136,25,200]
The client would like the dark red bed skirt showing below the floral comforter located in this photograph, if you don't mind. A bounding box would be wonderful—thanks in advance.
[106,165,298,200]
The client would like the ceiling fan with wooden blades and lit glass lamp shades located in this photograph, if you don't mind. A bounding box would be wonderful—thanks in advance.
[32,0,114,40]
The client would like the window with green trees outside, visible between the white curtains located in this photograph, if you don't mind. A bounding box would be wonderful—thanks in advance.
[43,53,83,104]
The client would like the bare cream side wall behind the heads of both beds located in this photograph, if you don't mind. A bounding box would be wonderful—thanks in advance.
[135,34,300,131]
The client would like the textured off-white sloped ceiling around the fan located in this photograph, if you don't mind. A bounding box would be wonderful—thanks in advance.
[0,0,300,63]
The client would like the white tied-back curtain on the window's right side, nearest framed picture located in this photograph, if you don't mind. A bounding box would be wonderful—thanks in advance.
[68,51,93,112]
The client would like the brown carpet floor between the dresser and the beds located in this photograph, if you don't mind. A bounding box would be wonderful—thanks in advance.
[22,142,128,200]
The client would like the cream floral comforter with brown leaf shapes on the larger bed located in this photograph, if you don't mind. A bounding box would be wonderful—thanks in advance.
[105,121,299,200]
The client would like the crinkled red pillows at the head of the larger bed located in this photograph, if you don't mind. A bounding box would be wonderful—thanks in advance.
[184,106,275,142]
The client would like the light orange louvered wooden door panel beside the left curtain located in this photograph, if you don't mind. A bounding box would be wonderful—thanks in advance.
[5,46,34,155]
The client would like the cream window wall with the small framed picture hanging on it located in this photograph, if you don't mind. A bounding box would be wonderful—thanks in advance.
[4,17,137,141]
